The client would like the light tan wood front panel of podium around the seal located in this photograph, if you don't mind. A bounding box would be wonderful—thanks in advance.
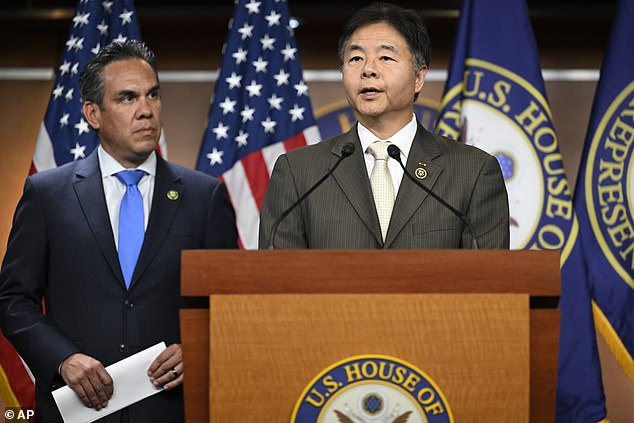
[210,294,529,423]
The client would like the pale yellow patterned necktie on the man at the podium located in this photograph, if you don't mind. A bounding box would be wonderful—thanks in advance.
[368,141,394,241]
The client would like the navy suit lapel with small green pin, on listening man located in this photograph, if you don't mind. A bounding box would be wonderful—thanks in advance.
[130,154,185,289]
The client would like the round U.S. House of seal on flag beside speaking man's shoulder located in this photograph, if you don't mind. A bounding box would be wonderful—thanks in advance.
[436,59,573,249]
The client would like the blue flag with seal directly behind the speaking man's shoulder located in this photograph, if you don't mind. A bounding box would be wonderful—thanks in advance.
[436,0,573,249]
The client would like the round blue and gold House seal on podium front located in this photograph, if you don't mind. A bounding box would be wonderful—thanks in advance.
[291,355,454,423]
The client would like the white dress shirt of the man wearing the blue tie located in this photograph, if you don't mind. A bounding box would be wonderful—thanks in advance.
[97,145,156,250]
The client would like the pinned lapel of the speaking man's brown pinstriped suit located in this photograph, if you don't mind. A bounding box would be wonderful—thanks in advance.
[385,124,443,248]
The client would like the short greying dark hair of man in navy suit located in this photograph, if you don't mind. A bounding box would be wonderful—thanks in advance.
[79,40,158,107]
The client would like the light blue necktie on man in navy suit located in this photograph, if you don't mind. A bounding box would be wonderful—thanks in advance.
[115,170,145,288]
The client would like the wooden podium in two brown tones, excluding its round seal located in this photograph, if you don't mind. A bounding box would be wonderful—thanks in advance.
[181,250,560,423]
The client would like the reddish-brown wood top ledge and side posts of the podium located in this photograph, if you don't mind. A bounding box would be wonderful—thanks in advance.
[181,250,559,422]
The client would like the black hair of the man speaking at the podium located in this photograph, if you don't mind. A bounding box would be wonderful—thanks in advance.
[339,3,431,72]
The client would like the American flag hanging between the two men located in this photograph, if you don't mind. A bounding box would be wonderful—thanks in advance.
[196,0,321,249]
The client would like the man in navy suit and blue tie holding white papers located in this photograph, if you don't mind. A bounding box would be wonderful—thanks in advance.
[0,41,237,423]
